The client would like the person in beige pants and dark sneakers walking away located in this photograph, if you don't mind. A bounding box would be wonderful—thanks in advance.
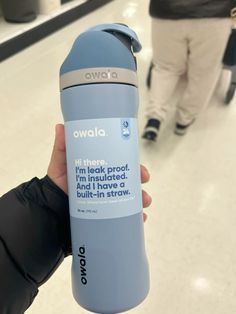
[142,0,236,141]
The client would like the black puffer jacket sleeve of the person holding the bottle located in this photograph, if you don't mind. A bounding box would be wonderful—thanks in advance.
[0,176,71,314]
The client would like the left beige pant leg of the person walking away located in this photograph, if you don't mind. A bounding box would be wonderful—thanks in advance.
[146,19,187,121]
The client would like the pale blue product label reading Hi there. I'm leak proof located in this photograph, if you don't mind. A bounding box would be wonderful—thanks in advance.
[65,118,142,219]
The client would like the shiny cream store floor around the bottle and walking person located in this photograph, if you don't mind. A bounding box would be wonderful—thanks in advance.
[0,0,236,314]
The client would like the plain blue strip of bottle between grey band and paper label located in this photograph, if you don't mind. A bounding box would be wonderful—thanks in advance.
[61,84,138,121]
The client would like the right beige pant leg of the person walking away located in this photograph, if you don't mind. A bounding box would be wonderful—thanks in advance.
[177,19,230,125]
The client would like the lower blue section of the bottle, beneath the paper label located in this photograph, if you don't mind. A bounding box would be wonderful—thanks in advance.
[71,213,149,314]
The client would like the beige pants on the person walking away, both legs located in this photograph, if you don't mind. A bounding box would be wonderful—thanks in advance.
[146,18,231,125]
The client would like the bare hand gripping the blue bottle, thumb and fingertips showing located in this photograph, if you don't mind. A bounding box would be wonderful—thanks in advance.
[48,124,152,221]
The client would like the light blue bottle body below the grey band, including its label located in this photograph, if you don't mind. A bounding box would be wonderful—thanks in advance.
[61,84,149,314]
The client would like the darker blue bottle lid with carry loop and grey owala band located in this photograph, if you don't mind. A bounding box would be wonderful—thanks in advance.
[60,24,141,89]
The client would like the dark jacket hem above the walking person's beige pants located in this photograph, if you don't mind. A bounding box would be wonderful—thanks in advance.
[149,0,236,19]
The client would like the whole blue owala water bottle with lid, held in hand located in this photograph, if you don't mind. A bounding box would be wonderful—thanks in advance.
[60,24,149,314]
